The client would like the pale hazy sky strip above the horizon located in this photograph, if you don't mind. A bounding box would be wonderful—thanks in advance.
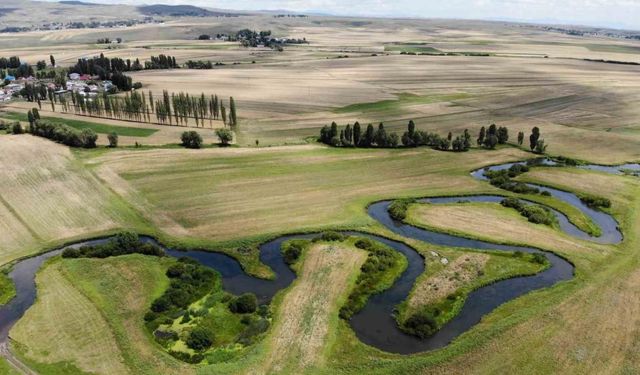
[48,0,640,30]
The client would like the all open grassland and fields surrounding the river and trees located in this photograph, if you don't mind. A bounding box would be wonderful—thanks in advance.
[0,11,640,375]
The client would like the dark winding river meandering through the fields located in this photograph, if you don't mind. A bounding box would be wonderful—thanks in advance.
[0,163,622,354]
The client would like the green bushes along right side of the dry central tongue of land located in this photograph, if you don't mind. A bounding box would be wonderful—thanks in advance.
[340,238,403,319]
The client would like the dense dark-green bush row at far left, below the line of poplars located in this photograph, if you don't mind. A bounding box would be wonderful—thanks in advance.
[29,118,98,148]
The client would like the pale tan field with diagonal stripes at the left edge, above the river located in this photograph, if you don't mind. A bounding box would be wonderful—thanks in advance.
[0,135,144,264]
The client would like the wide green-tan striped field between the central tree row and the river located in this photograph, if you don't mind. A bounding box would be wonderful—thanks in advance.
[88,146,526,244]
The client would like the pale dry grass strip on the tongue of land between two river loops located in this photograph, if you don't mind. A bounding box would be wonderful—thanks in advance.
[252,244,367,374]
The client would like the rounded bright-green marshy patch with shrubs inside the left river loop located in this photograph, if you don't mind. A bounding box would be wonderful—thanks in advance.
[145,257,270,363]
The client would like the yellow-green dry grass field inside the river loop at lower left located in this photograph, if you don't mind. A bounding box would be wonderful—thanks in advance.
[11,262,128,374]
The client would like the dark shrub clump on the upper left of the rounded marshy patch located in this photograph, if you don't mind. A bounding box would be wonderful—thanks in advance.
[145,257,217,318]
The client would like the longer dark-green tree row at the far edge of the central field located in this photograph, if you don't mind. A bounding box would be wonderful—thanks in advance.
[319,121,471,151]
